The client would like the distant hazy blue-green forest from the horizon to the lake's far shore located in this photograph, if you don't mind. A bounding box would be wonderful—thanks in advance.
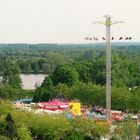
[0,43,140,75]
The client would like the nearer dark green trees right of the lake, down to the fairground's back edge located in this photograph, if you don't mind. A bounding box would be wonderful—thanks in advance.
[34,54,140,112]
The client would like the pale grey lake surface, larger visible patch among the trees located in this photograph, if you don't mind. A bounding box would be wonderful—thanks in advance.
[20,74,47,89]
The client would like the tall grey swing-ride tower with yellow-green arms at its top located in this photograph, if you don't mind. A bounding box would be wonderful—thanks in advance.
[95,15,123,121]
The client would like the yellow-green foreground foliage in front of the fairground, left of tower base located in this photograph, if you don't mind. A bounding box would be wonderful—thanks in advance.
[13,112,109,140]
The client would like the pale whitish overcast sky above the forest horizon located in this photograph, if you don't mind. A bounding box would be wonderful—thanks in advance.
[0,0,140,43]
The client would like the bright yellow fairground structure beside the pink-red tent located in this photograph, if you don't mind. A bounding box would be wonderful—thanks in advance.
[68,101,81,116]
